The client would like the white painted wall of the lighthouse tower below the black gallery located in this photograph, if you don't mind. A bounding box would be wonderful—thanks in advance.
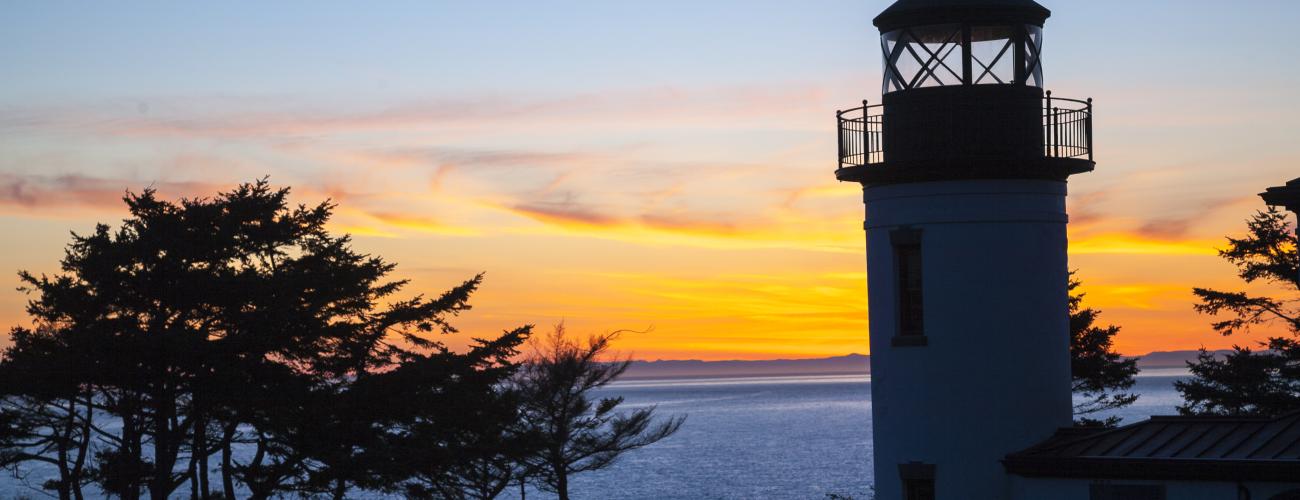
[863,181,1071,500]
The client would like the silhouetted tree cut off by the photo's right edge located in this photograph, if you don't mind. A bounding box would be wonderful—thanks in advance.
[1175,208,1300,416]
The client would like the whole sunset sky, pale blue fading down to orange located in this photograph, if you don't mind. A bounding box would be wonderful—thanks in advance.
[0,0,1300,360]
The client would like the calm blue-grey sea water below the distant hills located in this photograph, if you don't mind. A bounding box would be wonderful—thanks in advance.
[0,370,1186,500]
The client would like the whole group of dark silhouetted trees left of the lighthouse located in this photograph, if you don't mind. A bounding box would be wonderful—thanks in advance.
[0,182,681,499]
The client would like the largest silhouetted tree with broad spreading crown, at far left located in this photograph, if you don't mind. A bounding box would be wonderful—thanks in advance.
[0,181,528,499]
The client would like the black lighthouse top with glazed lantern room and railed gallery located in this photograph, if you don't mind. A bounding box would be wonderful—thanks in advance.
[836,0,1093,184]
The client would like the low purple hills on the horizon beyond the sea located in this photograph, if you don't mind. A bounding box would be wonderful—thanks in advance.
[621,351,1230,379]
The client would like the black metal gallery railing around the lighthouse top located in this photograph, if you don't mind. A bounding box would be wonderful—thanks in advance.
[836,92,1092,169]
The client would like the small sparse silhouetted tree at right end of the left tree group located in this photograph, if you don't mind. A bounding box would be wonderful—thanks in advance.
[516,323,685,500]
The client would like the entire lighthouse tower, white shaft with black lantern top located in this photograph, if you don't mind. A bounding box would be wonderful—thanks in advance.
[836,0,1093,500]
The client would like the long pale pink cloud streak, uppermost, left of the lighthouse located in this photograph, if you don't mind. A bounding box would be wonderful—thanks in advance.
[0,84,829,140]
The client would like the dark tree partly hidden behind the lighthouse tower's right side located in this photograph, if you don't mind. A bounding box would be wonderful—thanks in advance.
[1070,273,1138,427]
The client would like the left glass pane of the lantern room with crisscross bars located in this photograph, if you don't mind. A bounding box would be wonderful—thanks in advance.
[880,25,962,94]
